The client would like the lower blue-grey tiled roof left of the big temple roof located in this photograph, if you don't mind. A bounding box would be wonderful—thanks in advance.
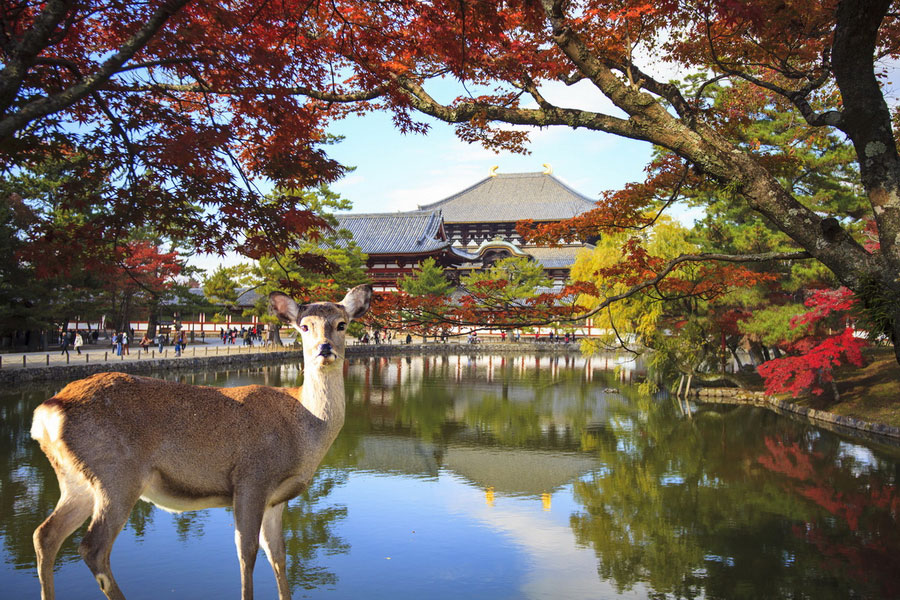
[335,210,450,254]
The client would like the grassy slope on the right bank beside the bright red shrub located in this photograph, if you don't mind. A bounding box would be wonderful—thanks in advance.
[786,348,900,427]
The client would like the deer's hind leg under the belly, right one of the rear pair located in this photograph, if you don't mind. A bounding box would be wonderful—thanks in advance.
[78,482,140,600]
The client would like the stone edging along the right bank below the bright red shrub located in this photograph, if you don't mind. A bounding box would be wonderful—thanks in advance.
[697,388,900,439]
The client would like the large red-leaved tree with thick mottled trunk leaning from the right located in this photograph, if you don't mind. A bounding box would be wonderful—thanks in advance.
[282,0,900,361]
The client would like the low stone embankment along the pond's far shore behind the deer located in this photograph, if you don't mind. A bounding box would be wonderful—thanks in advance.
[0,342,578,384]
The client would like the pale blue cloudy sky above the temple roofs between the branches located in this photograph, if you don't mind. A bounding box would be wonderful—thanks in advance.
[190,69,699,271]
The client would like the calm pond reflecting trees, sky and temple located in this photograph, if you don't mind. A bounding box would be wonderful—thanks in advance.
[0,356,900,600]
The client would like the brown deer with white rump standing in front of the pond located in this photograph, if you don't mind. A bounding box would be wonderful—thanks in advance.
[31,285,372,600]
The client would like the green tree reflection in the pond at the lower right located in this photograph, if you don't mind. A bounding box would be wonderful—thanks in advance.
[571,403,888,599]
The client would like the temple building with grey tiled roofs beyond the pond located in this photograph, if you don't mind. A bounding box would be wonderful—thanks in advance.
[338,169,594,290]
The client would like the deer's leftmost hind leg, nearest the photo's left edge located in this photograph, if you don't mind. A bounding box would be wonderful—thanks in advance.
[34,476,94,600]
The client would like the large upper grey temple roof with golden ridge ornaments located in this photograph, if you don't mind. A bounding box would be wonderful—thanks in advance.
[419,173,596,223]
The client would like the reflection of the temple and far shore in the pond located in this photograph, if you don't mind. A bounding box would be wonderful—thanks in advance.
[338,355,633,502]
